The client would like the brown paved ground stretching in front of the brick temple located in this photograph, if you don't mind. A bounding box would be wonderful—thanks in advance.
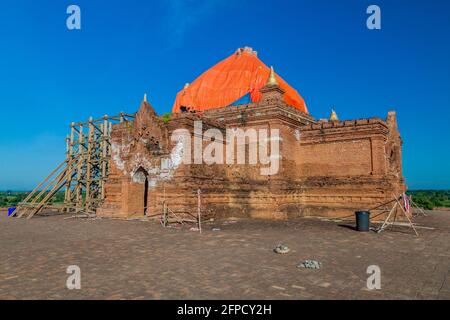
[0,212,450,299]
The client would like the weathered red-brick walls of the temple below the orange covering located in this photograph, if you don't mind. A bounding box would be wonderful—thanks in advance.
[97,84,404,219]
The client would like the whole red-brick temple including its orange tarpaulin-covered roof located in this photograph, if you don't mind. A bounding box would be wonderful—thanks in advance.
[97,48,405,219]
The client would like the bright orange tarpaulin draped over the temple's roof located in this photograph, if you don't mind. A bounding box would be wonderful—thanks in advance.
[172,48,308,113]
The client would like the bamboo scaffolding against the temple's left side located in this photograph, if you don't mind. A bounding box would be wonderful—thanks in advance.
[12,112,134,218]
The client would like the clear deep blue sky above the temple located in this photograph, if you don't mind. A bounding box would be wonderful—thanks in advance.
[0,0,450,190]
